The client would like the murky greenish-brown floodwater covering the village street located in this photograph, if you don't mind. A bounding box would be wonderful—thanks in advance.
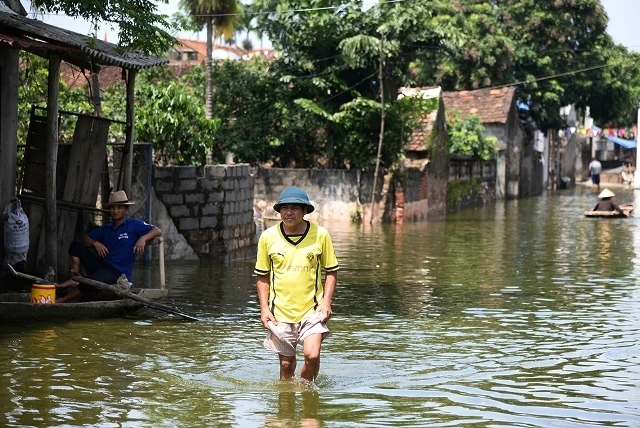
[0,188,640,427]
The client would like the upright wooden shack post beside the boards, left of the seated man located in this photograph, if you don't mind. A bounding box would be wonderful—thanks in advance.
[44,54,61,278]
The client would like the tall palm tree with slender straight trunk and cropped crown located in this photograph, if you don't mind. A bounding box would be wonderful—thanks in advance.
[180,0,243,119]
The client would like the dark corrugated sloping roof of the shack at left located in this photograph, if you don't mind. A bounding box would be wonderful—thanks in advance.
[0,1,168,70]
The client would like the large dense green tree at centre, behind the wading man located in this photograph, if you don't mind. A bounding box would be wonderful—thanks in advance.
[253,0,459,168]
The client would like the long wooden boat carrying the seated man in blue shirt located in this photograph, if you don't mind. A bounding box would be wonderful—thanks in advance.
[0,288,167,321]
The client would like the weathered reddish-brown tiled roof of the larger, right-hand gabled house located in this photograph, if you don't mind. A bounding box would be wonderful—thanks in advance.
[442,87,515,123]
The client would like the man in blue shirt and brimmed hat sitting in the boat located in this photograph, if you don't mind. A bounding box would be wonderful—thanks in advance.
[57,190,162,303]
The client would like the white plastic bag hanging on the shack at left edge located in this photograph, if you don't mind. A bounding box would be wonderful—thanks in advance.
[4,199,29,265]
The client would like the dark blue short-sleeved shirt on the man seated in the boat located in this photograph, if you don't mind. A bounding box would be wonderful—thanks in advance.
[88,217,153,281]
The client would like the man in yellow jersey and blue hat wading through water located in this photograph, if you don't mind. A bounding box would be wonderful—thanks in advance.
[255,187,339,381]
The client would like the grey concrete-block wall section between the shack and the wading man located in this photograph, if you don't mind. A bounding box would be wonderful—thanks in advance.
[154,165,255,262]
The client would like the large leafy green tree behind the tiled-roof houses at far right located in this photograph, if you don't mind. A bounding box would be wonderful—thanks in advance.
[414,0,640,129]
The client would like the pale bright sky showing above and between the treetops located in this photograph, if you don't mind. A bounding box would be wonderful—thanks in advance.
[22,0,640,52]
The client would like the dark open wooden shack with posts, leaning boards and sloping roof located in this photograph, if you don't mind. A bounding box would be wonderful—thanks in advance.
[0,0,167,280]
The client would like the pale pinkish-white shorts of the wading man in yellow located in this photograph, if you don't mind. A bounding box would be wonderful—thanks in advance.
[264,312,329,357]
